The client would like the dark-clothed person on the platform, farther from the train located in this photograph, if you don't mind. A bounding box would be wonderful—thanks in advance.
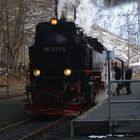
[125,66,132,95]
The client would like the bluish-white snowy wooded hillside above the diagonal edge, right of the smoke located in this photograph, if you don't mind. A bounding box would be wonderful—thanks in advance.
[93,0,140,44]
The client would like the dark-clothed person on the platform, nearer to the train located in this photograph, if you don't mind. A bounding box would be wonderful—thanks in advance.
[114,62,121,95]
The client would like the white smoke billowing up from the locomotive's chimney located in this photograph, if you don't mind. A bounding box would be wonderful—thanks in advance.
[58,0,97,34]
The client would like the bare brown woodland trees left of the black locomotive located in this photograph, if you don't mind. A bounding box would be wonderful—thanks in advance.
[0,0,52,69]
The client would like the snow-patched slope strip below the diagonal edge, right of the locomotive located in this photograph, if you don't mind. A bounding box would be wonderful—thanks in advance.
[91,25,140,64]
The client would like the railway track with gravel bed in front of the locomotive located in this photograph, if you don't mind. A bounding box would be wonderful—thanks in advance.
[0,117,65,140]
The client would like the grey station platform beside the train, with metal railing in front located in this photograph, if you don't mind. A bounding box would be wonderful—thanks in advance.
[71,82,140,137]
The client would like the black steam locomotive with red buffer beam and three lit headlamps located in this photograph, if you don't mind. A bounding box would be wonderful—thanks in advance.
[25,18,105,116]
